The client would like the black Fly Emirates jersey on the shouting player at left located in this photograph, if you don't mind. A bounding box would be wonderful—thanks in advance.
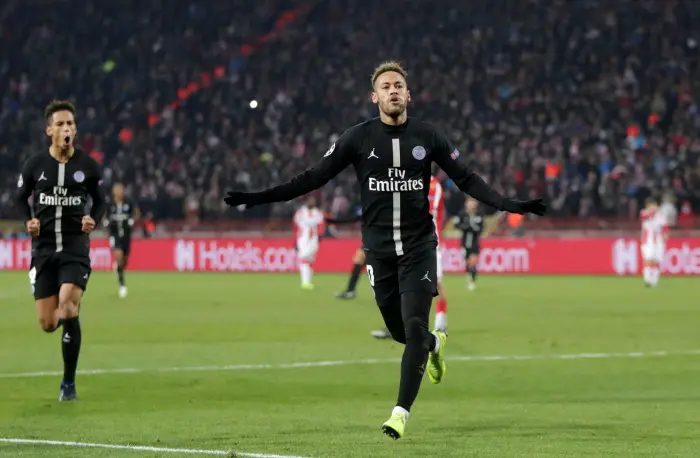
[17,149,106,256]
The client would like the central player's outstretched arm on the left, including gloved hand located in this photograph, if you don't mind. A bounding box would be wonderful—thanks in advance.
[224,130,354,208]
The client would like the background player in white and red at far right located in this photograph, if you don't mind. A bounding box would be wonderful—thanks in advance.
[639,198,668,287]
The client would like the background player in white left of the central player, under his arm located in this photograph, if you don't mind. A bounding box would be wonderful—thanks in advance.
[294,197,324,289]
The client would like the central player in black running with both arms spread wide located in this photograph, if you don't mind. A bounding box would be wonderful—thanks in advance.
[225,62,546,439]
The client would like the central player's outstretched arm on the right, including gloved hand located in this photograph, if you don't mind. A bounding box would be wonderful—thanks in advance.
[433,133,547,215]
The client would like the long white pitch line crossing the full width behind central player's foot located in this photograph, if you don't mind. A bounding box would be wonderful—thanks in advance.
[0,350,700,379]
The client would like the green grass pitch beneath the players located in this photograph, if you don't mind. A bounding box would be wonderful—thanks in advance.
[0,272,700,458]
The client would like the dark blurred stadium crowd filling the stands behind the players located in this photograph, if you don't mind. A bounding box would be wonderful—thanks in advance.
[0,0,700,219]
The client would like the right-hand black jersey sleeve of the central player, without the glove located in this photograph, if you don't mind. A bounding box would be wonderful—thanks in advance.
[433,131,503,210]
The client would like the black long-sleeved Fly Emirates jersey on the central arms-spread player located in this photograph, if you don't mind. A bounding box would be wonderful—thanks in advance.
[254,118,503,256]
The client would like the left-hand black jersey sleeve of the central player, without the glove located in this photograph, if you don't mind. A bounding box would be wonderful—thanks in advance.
[255,128,357,203]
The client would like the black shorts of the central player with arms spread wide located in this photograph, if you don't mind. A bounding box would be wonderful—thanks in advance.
[366,247,438,307]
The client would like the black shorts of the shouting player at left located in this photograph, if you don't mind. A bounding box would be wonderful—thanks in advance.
[29,253,92,300]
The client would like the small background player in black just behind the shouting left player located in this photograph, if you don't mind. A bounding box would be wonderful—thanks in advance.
[105,183,141,299]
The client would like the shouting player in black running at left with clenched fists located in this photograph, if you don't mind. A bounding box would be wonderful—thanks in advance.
[17,101,106,401]
